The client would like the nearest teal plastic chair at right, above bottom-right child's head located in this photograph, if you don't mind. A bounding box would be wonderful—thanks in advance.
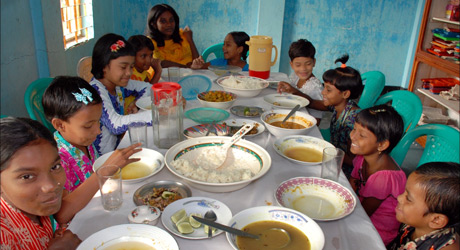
[390,124,460,167]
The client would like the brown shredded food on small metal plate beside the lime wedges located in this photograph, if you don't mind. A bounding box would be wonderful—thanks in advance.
[137,188,183,211]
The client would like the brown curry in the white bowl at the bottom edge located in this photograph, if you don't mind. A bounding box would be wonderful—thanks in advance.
[236,221,310,250]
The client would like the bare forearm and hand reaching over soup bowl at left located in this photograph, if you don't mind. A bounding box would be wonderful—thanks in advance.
[54,143,141,226]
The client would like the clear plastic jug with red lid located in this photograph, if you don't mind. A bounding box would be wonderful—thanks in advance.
[152,82,184,149]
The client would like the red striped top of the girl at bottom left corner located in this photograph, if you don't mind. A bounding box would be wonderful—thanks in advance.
[0,198,53,250]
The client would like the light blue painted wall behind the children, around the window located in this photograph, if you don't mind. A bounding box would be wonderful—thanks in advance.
[1,0,424,116]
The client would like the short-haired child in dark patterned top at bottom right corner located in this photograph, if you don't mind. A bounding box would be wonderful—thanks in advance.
[387,162,460,250]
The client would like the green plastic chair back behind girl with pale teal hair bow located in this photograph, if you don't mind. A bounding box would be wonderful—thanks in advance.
[24,78,56,133]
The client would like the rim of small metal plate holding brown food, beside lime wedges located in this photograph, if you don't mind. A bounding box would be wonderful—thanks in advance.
[133,181,192,209]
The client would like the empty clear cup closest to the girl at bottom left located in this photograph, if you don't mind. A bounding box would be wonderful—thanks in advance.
[96,165,123,211]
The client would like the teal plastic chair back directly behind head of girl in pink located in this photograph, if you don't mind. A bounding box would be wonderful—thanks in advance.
[375,90,423,133]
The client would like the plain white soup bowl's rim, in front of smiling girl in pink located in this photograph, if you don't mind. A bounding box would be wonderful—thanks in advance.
[273,135,334,166]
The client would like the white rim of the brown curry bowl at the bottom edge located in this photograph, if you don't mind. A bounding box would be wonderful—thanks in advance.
[226,206,324,250]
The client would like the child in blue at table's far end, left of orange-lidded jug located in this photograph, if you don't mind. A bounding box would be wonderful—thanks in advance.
[191,31,250,71]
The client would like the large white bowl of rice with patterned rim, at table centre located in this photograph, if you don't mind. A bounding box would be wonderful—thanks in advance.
[165,136,271,193]
